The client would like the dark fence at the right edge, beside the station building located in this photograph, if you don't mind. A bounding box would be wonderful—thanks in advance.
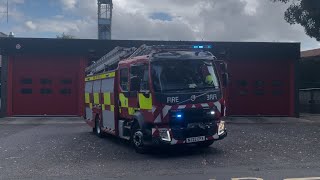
[299,88,320,114]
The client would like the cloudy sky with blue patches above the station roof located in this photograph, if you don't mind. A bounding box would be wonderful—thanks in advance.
[0,0,320,50]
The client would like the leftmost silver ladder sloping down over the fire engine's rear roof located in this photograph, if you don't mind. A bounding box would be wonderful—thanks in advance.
[85,46,137,74]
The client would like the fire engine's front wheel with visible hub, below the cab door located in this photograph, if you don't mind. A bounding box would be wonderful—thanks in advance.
[130,123,147,154]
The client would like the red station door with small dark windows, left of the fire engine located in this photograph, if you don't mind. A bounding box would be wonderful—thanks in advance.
[12,56,80,115]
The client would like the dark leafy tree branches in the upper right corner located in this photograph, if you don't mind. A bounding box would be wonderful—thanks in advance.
[271,0,320,41]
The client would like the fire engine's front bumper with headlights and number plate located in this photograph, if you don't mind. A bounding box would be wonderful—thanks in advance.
[152,121,227,145]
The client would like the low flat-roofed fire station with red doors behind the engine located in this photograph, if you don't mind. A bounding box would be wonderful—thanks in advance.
[0,38,300,116]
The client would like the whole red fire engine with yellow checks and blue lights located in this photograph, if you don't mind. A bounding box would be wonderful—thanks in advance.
[85,45,227,153]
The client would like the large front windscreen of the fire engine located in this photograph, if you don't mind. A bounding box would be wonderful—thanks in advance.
[152,60,219,91]
